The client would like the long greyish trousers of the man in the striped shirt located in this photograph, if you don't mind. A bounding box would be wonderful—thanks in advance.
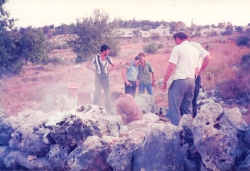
[94,74,111,112]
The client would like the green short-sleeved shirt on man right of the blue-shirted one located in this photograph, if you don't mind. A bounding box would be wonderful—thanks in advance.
[138,61,154,84]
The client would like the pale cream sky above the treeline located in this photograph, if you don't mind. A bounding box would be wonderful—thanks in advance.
[4,0,250,27]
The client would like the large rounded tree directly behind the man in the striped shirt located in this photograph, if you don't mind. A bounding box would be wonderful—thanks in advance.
[68,9,119,58]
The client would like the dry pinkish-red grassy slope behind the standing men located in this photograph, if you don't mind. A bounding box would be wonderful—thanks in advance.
[0,35,250,119]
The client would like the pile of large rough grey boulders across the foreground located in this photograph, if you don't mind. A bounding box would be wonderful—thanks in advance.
[0,102,250,171]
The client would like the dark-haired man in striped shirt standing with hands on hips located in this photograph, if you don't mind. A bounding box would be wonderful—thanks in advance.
[86,45,115,112]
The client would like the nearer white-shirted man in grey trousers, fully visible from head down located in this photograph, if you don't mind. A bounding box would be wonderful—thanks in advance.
[162,32,199,125]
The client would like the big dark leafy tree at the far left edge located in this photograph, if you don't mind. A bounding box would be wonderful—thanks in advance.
[0,0,47,76]
